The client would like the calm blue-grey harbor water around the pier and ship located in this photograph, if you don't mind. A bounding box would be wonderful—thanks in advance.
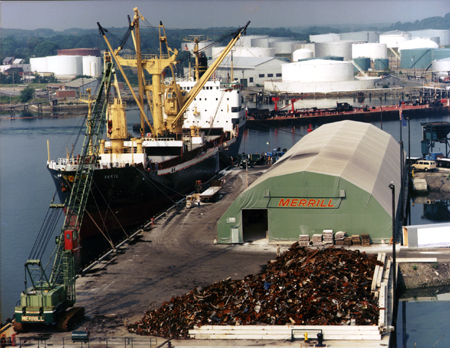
[0,99,450,348]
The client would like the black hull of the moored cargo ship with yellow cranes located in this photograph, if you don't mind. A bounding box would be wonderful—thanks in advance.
[49,148,219,240]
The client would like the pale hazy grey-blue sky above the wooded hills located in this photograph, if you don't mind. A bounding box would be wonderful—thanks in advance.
[0,0,450,31]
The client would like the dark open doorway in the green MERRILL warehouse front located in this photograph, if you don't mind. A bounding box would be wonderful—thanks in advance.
[242,209,269,242]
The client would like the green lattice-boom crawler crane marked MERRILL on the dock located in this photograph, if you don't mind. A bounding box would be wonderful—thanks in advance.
[14,52,114,331]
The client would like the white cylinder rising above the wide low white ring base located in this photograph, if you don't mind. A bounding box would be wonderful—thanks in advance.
[281,59,353,82]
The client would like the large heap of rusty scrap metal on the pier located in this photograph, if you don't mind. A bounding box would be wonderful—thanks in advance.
[128,243,382,338]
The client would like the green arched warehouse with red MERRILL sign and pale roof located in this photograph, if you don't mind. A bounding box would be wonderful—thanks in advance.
[217,121,405,243]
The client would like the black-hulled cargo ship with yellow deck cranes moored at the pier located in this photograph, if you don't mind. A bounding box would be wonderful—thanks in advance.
[47,8,249,253]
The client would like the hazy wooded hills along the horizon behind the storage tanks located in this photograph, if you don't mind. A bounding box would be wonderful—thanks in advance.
[0,13,450,63]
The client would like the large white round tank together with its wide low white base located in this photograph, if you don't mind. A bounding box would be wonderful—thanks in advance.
[264,59,379,93]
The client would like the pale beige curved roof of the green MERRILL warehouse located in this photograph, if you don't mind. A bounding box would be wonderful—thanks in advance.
[251,121,400,214]
